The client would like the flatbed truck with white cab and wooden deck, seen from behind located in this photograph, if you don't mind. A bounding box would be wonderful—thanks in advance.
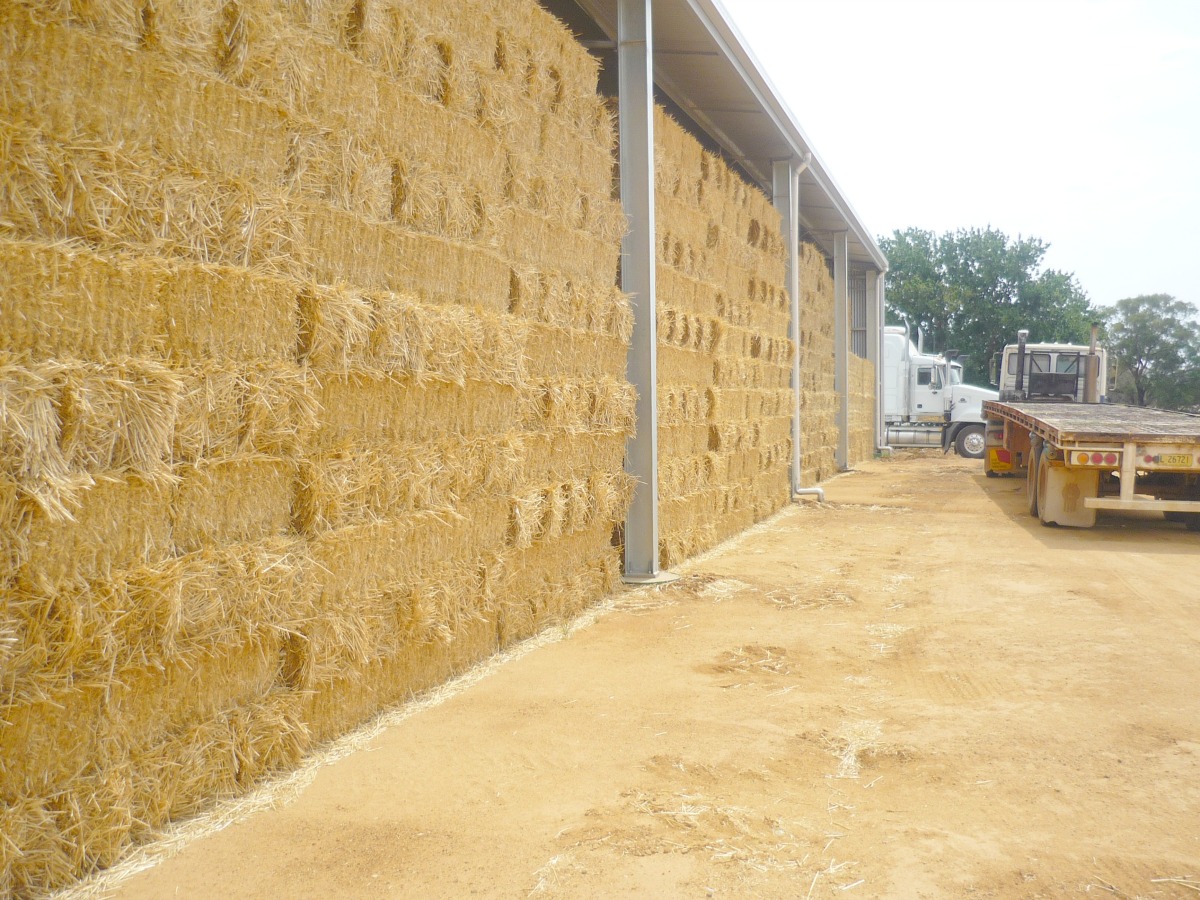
[984,331,1200,530]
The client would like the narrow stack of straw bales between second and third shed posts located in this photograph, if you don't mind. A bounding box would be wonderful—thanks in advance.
[800,244,839,486]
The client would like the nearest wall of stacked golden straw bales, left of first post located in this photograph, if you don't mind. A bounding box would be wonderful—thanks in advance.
[0,0,634,895]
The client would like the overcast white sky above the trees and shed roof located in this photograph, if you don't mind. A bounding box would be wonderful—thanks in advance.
[721,0,1200,306]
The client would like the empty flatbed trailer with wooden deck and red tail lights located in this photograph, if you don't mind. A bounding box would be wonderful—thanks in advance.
[983,400,1200,530]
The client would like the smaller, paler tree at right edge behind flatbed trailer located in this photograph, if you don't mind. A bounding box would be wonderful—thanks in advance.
[1106,294,1200,409]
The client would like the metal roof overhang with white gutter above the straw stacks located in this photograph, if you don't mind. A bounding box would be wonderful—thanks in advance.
[544,0,887,271]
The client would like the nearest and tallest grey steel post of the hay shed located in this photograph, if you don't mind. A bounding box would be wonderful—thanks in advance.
[617,0,659,580]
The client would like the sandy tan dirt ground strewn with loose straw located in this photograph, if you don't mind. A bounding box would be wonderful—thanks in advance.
[87,451,1200,900]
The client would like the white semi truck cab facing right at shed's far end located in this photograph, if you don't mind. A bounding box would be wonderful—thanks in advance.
[883,325,996,460]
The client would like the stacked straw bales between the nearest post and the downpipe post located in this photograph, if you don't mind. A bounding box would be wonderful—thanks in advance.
[654,110,792,565]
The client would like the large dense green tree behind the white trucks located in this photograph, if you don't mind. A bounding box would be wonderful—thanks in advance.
[880,228,1097,384]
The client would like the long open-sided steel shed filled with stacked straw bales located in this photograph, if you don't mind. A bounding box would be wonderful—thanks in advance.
[0,0,886,896]
